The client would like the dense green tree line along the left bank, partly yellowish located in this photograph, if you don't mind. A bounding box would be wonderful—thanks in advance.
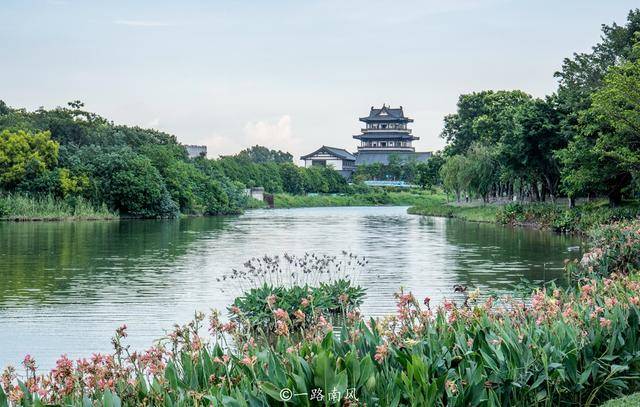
[0,101,348,217]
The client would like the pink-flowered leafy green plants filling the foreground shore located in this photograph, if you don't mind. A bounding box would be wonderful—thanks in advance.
[0,220,640,406]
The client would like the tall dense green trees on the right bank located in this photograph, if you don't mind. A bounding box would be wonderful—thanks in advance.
[440,10,640,205]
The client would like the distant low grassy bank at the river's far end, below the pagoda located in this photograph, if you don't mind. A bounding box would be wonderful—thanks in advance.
[274,190,437,208]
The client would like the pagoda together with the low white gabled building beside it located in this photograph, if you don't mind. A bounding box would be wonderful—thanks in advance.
[300,104,432,178]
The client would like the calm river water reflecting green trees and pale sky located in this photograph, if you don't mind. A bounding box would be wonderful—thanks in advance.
[0,207,580,368]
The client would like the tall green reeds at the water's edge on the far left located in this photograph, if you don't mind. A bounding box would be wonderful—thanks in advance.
[0,194,118,221]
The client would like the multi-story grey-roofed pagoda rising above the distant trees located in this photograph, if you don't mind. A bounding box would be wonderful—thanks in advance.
[353,105,431,165]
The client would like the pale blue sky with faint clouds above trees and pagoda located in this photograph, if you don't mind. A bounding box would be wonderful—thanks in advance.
[0,0,639,162]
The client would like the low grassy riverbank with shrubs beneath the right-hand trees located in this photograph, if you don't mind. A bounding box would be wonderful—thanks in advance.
[408,195,640,234]
